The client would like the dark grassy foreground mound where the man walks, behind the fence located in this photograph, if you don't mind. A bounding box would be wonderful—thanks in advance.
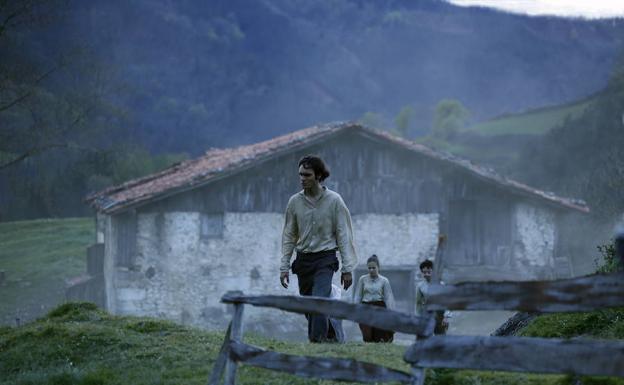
[0,303,584,385]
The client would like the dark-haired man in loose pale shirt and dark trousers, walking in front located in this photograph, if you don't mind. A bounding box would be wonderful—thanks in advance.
[280,156,357,342]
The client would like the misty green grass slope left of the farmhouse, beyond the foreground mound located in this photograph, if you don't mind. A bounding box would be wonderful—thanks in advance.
[0,218,95,325]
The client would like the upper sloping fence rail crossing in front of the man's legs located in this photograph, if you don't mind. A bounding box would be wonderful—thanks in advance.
[221,292,429,336]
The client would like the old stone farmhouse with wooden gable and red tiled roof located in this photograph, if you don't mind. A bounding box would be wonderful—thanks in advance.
[73,123,589,335]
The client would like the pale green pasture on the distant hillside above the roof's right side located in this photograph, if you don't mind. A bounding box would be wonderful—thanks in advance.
[464,98,593,136]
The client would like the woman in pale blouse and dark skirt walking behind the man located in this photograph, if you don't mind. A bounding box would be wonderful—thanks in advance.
[353,254,394,342]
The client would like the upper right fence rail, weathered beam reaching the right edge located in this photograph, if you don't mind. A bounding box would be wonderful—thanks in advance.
[427,273,624,312]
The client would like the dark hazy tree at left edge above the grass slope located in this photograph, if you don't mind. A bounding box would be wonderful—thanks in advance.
[0,0,135,220]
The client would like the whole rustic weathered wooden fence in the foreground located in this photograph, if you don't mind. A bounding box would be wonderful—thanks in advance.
[208,273,624,385]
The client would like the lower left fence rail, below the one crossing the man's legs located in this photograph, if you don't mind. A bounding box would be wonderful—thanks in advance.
[230,341,411,383]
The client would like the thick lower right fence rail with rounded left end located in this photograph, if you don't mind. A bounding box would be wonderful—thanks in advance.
[404,336,624,377]
